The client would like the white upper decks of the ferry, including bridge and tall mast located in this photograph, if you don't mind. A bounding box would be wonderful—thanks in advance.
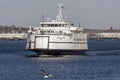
[29,3,83,34]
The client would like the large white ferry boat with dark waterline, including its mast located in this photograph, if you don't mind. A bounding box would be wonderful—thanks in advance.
[26,3,88,55]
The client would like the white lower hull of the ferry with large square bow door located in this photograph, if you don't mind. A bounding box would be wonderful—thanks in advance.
[27,34,88,52]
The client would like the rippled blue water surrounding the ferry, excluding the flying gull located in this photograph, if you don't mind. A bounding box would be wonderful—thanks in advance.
[0,40,120,80]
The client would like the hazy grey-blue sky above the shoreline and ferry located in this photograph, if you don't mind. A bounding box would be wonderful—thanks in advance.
[0,0,120,29]
